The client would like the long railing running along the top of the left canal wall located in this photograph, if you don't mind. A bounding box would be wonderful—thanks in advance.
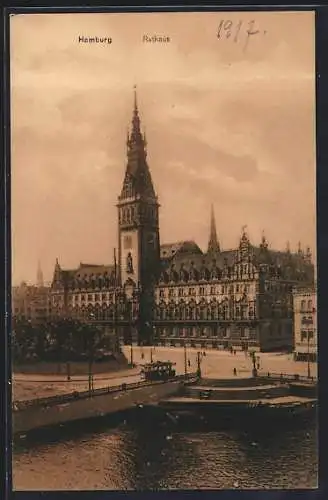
[12,373,197,412]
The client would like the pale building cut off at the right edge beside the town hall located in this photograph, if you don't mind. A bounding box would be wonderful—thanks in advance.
[293,286,318,361]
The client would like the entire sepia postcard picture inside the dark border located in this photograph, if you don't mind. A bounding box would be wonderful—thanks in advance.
[9,10,318,491]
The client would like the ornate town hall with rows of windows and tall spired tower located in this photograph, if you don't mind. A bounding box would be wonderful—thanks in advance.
[51,94,314,351]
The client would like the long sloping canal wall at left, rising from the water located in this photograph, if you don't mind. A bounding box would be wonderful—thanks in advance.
[12,380,184,434]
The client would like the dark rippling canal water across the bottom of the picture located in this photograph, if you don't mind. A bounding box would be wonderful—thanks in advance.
[13,412,318,490]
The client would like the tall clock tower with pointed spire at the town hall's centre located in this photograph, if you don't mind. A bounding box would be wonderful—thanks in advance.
[117,88,160,343]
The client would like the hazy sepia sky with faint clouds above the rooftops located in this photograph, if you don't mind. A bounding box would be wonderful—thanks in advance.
[11,12,315,283]
